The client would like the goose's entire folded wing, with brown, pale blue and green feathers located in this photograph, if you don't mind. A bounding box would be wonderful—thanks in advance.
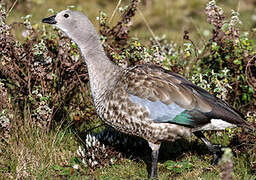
[125,65,246,127]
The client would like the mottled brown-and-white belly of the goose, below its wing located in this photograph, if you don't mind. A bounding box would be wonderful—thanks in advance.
[96,101,191,143]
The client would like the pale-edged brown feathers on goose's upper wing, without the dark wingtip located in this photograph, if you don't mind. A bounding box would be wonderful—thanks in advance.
[126,66,211,112]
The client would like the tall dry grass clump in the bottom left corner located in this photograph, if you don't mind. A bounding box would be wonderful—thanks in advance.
[0,115,78,179]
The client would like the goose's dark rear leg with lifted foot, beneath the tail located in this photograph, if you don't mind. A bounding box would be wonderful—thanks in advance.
[194,131,223,165]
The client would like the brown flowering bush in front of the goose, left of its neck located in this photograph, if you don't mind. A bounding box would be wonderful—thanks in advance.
[0,2,97,130]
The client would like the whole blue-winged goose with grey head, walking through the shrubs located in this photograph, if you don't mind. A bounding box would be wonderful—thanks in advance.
[42,10,248,178]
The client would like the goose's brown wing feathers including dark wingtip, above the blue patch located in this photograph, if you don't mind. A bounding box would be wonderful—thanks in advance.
[125,65,246,125]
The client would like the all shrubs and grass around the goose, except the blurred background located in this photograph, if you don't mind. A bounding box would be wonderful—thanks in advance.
[0,0,256,179]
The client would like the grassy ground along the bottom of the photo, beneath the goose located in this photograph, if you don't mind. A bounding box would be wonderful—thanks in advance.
[0,119,256,180]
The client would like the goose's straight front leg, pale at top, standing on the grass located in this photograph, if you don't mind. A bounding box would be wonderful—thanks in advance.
[149,142,160,179]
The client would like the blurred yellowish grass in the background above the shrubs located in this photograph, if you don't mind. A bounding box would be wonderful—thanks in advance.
[5,0,254,45]
